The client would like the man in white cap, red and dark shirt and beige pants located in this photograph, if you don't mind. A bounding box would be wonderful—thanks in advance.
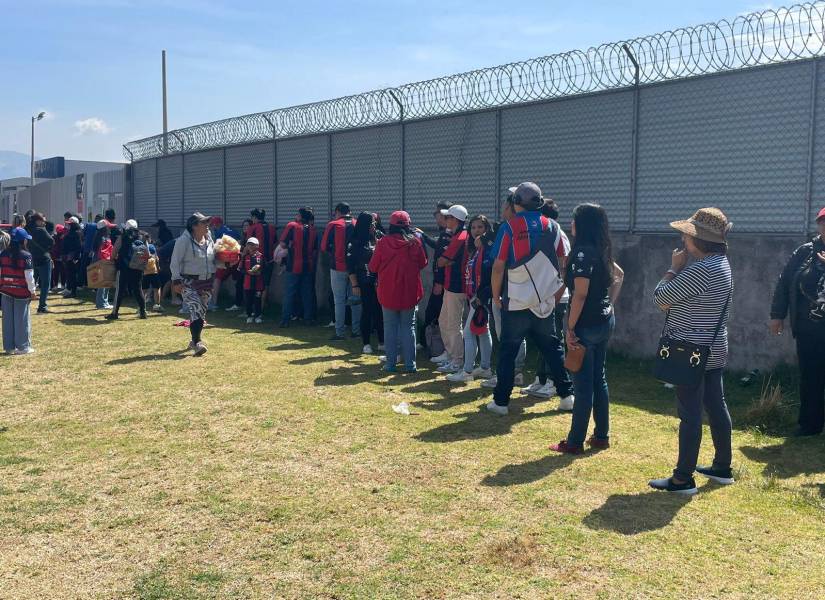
[433,204,468,373]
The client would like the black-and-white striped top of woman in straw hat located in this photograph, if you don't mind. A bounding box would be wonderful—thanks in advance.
[653,254,733,369]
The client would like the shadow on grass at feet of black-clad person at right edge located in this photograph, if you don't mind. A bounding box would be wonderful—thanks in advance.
[739,435,825,478]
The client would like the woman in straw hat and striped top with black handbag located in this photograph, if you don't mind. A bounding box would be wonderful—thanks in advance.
[650,208,734,496]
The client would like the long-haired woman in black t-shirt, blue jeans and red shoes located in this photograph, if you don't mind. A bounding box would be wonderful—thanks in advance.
[550,204,621,454]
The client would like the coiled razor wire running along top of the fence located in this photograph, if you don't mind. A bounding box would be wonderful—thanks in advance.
[124,1,825,161]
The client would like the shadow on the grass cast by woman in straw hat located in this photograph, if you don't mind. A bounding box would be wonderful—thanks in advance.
[582,484,718,535]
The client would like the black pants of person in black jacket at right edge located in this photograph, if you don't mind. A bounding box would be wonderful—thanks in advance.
[796,327,825,433]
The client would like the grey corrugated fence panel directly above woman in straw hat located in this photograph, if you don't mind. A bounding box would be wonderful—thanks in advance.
[637,63,811,233]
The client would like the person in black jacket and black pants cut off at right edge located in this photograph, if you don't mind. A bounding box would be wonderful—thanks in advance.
[770,208,825,437]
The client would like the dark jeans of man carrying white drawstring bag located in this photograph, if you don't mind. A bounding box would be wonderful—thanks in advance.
[493,310,558,406]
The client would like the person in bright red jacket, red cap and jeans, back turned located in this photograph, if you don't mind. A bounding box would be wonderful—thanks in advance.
[367,210,427,373]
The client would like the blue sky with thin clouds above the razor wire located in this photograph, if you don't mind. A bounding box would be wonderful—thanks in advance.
[0,0,768,160]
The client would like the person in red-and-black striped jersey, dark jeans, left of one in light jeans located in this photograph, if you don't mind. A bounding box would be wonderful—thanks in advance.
[280,206,318,327]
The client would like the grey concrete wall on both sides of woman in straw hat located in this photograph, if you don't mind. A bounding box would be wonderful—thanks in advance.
[612,233,804,370]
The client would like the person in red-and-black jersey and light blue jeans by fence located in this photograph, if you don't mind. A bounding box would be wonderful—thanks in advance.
[321,202,361,340]
